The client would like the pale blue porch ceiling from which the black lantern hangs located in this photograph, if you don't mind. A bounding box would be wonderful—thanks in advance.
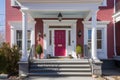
[29,11,89,18]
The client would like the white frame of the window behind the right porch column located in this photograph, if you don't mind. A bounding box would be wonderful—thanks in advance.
[83,21,109,59]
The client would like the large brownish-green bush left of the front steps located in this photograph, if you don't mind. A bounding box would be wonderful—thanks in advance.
[0,43,21,74]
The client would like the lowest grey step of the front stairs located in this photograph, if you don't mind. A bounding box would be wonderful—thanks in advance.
[29,72,91,76]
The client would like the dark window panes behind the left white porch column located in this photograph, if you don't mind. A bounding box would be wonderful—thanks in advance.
[16,30,31,50]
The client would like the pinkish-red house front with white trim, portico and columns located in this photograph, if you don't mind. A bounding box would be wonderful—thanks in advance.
[5,0,115,61]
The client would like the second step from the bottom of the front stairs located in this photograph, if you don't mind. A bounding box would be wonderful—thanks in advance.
[30,68,91,72]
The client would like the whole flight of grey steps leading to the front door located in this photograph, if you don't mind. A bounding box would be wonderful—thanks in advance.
[29,59,92,76]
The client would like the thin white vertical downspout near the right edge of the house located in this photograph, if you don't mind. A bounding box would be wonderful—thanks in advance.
[113,0,117,56]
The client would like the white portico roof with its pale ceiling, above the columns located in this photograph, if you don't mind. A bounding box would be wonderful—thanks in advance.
[16,0,103,20]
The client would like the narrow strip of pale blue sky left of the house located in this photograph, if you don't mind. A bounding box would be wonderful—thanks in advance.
[0,0,5,32]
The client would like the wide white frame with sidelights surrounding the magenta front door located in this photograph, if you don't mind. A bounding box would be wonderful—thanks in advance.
[43,20,77,58]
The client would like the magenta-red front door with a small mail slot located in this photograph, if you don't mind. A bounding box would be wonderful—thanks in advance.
[54,30,66,56]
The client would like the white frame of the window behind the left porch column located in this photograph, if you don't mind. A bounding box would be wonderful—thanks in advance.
[9,21,35,50]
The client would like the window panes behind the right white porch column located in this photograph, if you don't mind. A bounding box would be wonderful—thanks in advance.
[88,29,102,49]
